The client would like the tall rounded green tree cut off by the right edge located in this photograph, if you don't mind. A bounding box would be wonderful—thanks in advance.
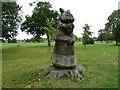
[106,9,120,45]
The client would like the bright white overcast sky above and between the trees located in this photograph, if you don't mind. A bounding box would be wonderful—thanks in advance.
[17,0,120,39]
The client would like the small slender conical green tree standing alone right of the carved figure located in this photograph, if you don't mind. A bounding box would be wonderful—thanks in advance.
[82,24,93,46]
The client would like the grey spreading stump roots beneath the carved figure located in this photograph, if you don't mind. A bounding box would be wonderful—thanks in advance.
[44,65,87,81]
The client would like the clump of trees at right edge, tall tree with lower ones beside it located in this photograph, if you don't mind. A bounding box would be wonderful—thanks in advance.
[98,9,120,45]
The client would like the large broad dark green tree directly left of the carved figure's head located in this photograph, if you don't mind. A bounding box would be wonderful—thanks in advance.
[21,1,58,46]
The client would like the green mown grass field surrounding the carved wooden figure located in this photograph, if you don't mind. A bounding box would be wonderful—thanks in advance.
[2,42,118,88]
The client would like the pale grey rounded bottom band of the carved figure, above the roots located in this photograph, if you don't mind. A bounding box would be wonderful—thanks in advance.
[52,52,77,69]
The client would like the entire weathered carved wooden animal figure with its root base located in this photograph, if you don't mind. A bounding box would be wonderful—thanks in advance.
[45,8,86,80]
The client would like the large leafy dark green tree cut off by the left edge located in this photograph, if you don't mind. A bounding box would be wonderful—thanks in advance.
[2,2,22,41]
